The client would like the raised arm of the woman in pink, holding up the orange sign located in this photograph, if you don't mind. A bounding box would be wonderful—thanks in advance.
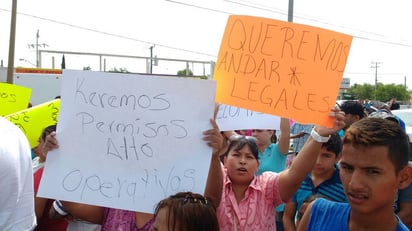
[279,109,345,201]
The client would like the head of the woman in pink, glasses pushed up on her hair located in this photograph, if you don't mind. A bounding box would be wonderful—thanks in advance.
[223,136,259,184]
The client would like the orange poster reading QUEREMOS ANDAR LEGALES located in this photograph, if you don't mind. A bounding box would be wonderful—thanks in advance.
[214,15,352,126]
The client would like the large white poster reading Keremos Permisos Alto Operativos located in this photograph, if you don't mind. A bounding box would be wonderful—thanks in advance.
[40,71,215,212]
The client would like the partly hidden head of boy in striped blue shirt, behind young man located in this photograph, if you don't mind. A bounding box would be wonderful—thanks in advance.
[312,133,342,177]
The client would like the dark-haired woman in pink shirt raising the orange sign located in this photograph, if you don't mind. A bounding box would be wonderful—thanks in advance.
[206,109,344,230]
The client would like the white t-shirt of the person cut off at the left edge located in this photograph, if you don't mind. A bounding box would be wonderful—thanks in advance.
[0,116,36,230]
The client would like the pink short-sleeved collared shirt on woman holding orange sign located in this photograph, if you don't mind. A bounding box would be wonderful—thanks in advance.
[216,167,284,231]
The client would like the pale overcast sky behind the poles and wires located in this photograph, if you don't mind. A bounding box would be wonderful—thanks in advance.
[0,0,412,90]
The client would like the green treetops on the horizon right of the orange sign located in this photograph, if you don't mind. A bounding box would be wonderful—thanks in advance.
[347,83,412,102]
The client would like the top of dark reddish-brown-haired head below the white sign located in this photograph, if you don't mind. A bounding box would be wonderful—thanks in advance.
[153,192,219,231]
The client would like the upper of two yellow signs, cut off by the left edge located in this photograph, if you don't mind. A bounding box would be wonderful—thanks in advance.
[0,83,31,116]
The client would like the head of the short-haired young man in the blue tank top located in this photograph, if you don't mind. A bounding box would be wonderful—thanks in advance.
[340,118,411,214]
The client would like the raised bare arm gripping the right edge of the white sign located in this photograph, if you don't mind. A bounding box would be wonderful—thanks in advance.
[203,119,223,208]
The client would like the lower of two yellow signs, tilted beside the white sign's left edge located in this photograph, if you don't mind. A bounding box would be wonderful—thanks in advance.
[5,99,60,147]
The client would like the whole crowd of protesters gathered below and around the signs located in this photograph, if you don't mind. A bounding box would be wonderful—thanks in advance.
[0,98,412,231]
